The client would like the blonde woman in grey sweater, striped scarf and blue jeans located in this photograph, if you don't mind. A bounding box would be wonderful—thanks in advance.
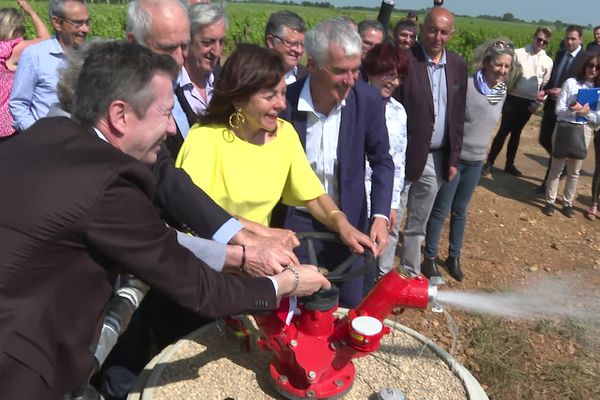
[425,38,518,281]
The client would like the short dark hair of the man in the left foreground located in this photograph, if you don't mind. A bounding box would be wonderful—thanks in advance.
[71,41,178,127]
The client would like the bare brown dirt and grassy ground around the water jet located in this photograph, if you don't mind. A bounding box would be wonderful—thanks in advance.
[400,116,600,400]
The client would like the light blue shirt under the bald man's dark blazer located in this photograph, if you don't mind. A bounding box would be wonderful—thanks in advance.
[425,51,448,150]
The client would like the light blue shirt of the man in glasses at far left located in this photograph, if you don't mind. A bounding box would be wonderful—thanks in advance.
[9,37,65,131]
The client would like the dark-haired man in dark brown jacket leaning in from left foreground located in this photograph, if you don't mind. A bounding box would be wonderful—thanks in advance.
[0,42,329,400]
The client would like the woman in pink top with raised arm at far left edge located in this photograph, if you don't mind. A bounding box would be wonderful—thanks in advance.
[0,0,50,141]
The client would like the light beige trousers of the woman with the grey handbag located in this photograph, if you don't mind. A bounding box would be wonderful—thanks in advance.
[546,124,594,206]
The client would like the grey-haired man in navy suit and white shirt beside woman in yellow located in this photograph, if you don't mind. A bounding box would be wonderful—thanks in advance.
[281,20,394,306]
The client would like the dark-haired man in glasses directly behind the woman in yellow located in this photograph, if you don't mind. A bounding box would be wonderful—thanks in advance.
[265,10,308,85]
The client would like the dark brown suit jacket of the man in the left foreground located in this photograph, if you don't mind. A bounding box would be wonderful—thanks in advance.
[0,117,276,399]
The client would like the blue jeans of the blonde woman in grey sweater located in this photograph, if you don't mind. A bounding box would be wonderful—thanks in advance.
[425,160,483,258]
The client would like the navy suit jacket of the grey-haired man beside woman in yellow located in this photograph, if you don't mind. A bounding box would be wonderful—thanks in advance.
[281,79,394,230]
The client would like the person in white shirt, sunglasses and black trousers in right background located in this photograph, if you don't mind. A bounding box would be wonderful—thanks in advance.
[481,26,553,176]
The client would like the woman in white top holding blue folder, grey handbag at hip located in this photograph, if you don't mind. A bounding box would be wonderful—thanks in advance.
[542,53,600,218]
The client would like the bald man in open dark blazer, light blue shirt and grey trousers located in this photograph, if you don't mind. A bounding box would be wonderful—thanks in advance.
[388,7,467,283]
